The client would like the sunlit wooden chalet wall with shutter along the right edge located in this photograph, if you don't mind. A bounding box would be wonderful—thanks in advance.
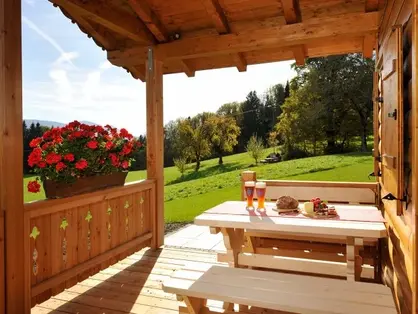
[374,0,417,313]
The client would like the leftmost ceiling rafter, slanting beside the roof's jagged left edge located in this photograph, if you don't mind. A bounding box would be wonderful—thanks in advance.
[49,0,154,44]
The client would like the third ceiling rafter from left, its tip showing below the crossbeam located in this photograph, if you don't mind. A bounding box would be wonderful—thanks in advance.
[201,0,247,72]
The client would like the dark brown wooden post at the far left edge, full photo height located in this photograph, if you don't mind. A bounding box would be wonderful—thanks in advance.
[0,0,30,313]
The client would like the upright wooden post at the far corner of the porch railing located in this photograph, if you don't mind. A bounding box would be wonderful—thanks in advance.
[146,47,164,248]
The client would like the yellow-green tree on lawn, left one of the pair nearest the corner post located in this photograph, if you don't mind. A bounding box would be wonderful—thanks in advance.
[178,113,213,171]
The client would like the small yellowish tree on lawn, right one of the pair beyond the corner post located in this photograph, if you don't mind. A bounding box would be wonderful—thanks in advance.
[207,115,241,165]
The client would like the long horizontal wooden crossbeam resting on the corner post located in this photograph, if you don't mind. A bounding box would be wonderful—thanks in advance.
[108,12,378,65]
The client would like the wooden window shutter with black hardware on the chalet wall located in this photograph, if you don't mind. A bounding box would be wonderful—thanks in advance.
[378,26,404,214]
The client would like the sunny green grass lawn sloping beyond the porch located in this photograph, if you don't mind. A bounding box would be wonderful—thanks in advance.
[24,152,374,222]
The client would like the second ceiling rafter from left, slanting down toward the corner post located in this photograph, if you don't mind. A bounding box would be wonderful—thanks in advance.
[128,0,169,42]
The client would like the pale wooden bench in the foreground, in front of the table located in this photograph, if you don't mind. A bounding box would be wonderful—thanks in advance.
[163,266,397,314]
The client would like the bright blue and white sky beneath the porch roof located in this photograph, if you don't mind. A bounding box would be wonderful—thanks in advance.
[22,0,294,135]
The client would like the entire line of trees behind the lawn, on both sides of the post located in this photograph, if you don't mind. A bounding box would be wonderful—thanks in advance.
[23,54,374,177]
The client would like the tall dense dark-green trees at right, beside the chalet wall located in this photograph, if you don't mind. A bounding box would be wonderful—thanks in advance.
[275,54,374,155]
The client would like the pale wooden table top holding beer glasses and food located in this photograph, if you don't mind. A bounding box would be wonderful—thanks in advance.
[194,202,387,238]
